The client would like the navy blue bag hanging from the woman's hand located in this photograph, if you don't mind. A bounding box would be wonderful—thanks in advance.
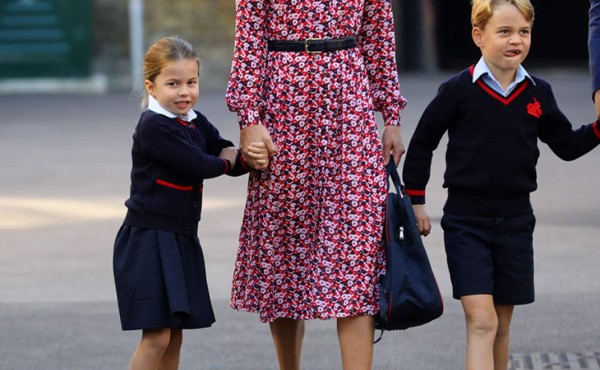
[375,159,444,341]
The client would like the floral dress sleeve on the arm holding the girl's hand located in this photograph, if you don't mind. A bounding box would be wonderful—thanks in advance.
[225,0,267,128]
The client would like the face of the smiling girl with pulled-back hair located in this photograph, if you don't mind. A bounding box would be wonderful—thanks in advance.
[144,59,199,115]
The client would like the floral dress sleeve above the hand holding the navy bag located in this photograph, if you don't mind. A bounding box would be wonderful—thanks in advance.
[358,0,406,125]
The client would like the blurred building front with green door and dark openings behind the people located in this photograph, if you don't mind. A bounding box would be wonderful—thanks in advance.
[0,0,589,93]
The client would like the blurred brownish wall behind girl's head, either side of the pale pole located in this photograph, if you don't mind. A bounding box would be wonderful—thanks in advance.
[92,0,235,91]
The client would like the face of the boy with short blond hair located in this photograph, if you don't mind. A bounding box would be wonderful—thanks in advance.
[472,4,531,78]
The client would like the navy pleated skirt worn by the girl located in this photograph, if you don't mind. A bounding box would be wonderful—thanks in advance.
[113,225,215,330]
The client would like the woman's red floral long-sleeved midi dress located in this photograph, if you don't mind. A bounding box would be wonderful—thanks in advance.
[226,0,406,322]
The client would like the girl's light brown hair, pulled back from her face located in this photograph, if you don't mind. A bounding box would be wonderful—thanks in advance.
[142,36,200,107]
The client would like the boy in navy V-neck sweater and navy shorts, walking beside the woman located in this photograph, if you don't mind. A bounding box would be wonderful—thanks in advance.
[403,0,600,370]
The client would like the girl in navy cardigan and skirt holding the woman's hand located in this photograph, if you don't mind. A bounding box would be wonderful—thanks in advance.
[113,37,268,369]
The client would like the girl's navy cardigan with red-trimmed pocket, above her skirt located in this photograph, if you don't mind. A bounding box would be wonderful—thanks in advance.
[124,110,249,235]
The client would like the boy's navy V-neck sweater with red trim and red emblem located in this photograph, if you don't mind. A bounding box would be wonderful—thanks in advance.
[403,67,600,217]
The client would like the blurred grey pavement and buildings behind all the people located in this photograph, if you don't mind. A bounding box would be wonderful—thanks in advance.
[0,0,600,370]
